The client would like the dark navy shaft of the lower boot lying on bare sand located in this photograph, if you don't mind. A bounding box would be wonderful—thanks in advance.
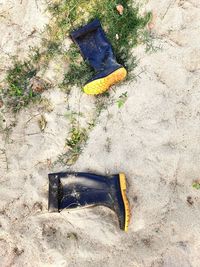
[49,172,118,211]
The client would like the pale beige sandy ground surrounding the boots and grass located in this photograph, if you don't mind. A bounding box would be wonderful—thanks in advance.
[0,0,200,267]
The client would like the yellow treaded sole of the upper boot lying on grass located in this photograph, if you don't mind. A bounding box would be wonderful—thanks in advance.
[83,68,127,95]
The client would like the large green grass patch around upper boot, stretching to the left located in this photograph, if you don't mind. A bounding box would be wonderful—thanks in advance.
[4,0,151,111]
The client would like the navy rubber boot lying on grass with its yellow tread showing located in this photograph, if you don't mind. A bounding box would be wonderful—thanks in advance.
[71,19,127,95]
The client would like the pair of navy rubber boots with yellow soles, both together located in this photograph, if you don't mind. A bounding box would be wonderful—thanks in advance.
[49,20,130,231]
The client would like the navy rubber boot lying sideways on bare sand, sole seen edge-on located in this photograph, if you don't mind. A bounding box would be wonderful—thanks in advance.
[48,172,130,231]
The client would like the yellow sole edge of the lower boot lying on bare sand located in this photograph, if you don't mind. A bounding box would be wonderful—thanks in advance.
[119,173,131,232]
